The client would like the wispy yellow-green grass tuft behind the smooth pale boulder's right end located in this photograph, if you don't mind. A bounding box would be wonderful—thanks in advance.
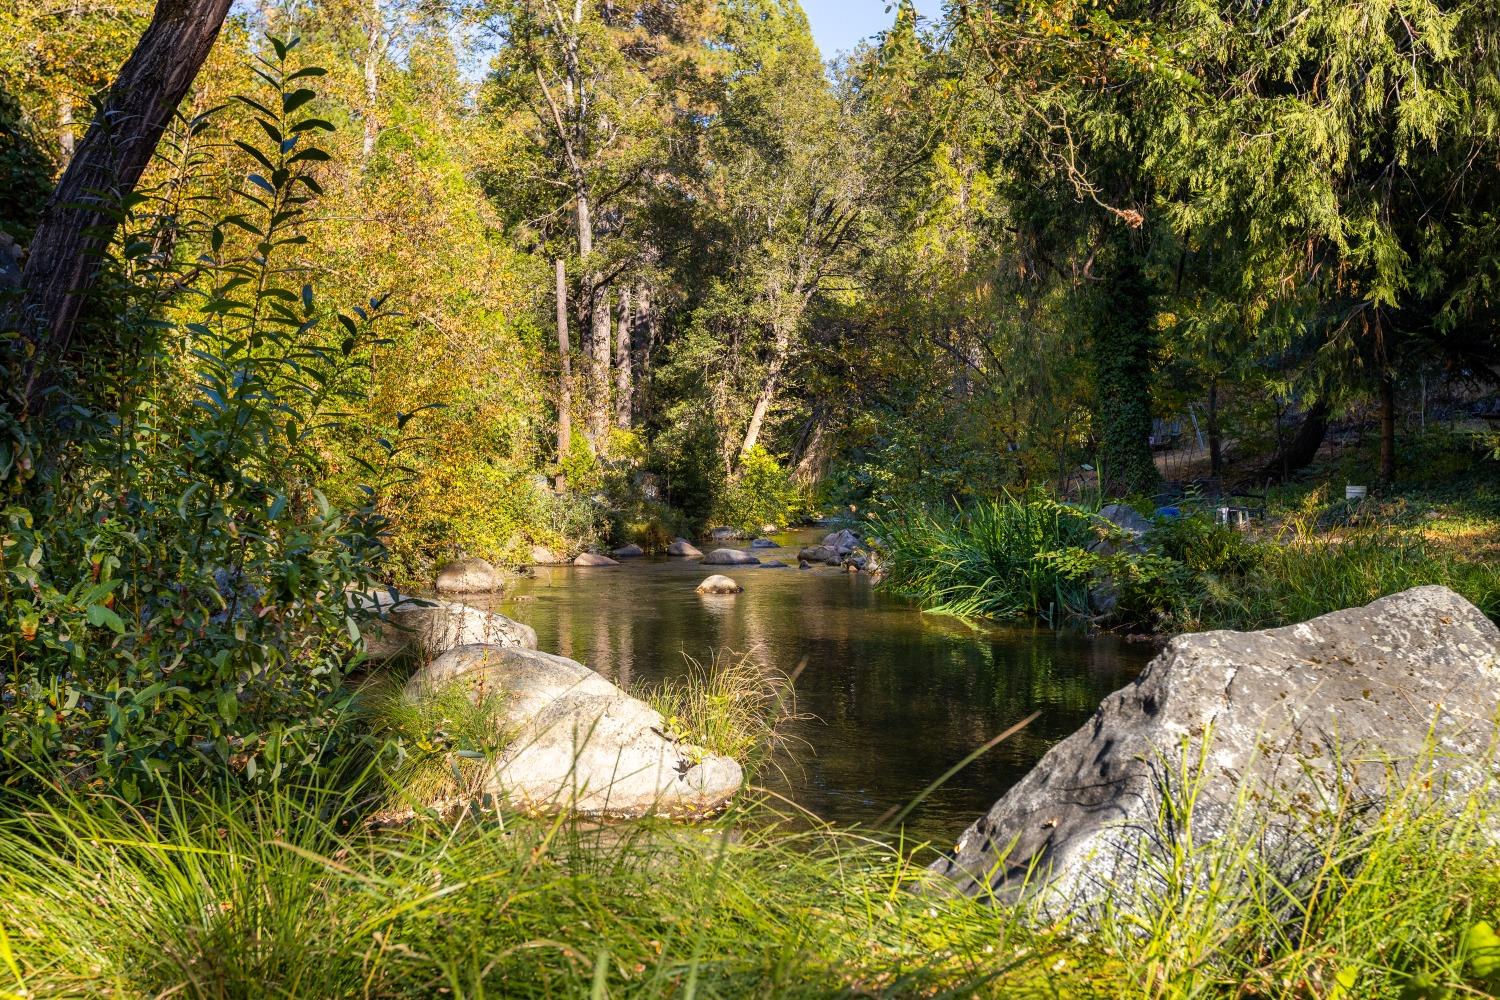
[635,649,798,775]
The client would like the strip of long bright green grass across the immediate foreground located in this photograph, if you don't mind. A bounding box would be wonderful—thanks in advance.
[0,755,1500,1000]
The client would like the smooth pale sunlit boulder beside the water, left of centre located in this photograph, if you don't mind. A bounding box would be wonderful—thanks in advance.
[407,645,744,817]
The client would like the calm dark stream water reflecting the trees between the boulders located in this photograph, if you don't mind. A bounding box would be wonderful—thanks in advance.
[495,531,1151,844]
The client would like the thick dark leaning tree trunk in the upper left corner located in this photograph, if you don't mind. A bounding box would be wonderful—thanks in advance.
[20,0,231,406]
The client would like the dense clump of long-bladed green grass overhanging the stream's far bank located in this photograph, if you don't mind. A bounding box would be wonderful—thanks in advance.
[879,493,1095,624]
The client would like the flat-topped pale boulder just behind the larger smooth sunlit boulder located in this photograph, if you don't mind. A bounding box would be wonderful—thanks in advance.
[354,591,537,663]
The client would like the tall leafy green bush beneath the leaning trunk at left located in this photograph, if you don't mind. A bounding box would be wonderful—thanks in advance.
[0,39,399,796]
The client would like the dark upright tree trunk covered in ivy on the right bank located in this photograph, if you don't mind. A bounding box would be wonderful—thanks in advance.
[1091,247,1161,496]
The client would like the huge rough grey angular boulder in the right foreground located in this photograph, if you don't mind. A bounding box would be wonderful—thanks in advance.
[933,586,1500,916]
